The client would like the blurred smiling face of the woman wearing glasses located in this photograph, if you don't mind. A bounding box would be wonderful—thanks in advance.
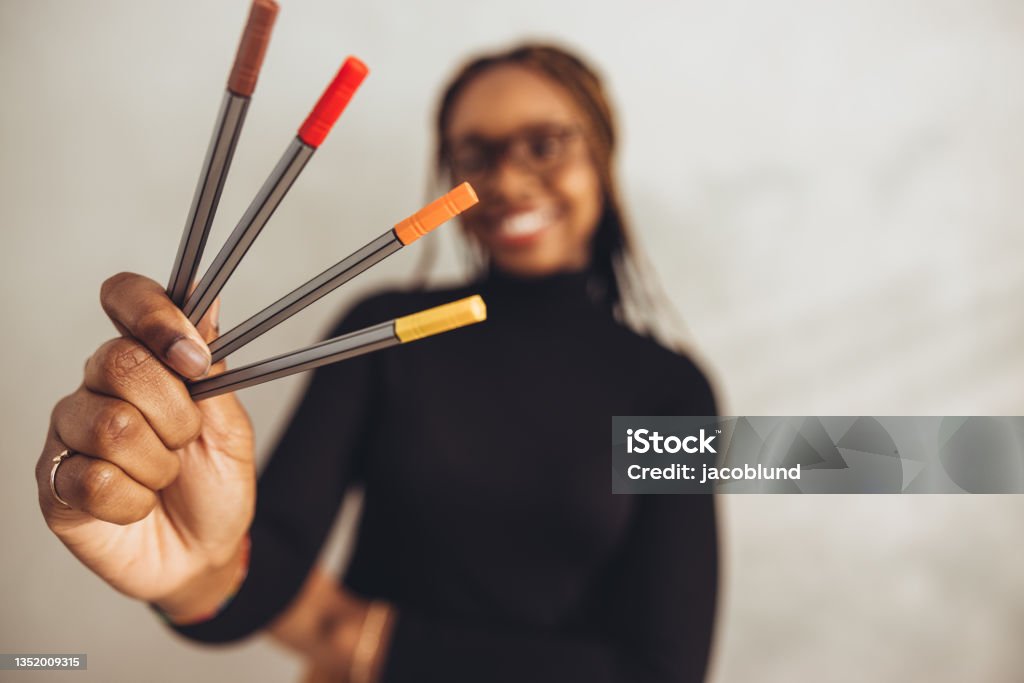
[444,65,603,276]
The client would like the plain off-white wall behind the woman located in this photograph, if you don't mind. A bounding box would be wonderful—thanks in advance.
[0,0,1024,683]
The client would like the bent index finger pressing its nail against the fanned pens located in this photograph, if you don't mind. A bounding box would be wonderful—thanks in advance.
[99,272,210,379]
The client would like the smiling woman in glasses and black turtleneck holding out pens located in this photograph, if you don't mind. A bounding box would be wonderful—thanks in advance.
[37,46,718,683]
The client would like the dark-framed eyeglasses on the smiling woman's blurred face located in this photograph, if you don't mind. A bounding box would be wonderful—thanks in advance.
[446,124,581,182]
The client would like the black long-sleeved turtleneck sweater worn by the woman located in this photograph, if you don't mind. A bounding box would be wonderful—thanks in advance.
[177,273,718,683]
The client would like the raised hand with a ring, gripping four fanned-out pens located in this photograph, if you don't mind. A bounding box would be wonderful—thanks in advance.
[36,273,256,617]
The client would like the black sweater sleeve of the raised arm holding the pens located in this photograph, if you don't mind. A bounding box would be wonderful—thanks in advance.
[172,302,380,642]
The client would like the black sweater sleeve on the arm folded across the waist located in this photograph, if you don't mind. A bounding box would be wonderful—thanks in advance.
[383,362,719,683]
